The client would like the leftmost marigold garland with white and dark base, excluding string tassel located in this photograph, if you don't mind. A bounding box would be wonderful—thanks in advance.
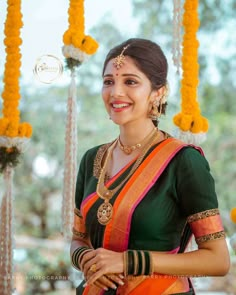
[0,0,32,172]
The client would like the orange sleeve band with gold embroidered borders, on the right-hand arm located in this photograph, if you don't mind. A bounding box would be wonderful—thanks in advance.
[187,209,225,244]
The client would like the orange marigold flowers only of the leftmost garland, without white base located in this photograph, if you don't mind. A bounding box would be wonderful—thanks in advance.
[0,0,32,138]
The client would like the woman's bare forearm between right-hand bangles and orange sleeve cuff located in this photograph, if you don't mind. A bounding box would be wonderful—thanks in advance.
[152,240,230,276]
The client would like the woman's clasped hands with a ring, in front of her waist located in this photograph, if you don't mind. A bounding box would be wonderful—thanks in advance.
[80,248,124,289]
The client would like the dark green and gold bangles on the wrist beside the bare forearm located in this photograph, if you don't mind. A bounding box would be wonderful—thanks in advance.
[123,250,154,277]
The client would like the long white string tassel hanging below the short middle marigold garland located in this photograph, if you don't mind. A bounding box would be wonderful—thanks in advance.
[62,70,77,240]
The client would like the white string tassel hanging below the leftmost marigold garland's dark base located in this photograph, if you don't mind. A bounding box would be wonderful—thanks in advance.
[0,166,14,295]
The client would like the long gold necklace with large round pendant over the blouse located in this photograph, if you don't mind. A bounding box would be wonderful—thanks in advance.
[96,128,158,225]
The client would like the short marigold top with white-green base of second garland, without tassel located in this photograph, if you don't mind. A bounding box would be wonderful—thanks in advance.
[62,0,98,69]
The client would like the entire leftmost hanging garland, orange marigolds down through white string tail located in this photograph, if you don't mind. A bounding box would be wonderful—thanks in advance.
[0,0,32,295]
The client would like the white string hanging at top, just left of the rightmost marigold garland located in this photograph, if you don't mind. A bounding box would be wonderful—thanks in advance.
[172,0,183,74]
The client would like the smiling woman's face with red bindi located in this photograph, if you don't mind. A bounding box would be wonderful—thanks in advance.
[102,56,157,125]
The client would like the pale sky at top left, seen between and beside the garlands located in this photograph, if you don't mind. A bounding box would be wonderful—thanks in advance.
[0,0,135,80]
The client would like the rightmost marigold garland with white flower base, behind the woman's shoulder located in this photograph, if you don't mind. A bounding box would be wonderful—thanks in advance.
[173,0,208,143]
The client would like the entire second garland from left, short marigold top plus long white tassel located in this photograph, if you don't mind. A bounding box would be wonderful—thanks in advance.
[62,0,98,239]
